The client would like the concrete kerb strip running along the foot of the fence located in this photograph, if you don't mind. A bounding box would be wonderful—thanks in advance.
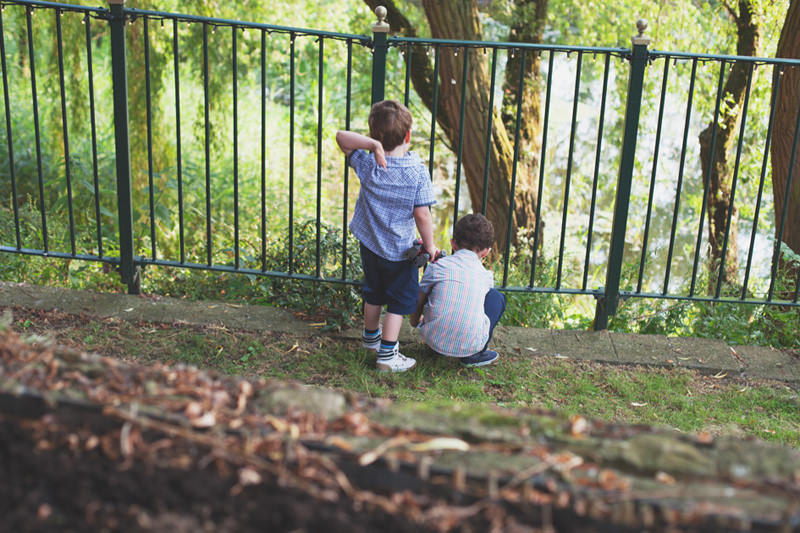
[0,282,800,383]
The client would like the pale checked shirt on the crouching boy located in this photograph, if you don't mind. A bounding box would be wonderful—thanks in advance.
[417,248,494,357]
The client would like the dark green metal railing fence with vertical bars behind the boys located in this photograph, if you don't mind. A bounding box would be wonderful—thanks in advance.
[0,0,800,328]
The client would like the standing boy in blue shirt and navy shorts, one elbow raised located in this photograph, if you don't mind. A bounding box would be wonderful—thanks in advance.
[336,100,438,372]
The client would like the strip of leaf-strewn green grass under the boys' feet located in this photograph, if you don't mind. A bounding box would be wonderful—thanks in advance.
[13,311,800,447]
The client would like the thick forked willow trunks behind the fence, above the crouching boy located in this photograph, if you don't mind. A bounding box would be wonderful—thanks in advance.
[364,0,547,254]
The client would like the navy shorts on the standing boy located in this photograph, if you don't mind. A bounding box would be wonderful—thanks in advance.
[361,244,419,315]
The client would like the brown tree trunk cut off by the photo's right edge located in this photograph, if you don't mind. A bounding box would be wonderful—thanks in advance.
[770,0,800,288]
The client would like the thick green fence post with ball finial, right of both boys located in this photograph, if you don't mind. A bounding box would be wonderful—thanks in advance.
[594,19,650,330]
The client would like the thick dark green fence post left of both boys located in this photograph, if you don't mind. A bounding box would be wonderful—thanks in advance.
[108,0,141,294]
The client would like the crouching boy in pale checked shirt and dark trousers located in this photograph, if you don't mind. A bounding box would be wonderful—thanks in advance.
[410,214,506,366]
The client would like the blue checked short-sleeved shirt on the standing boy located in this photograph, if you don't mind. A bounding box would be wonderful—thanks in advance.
[350,150,436,261]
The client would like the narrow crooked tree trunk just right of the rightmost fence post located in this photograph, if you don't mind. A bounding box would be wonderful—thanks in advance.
[700,0,759,286]
